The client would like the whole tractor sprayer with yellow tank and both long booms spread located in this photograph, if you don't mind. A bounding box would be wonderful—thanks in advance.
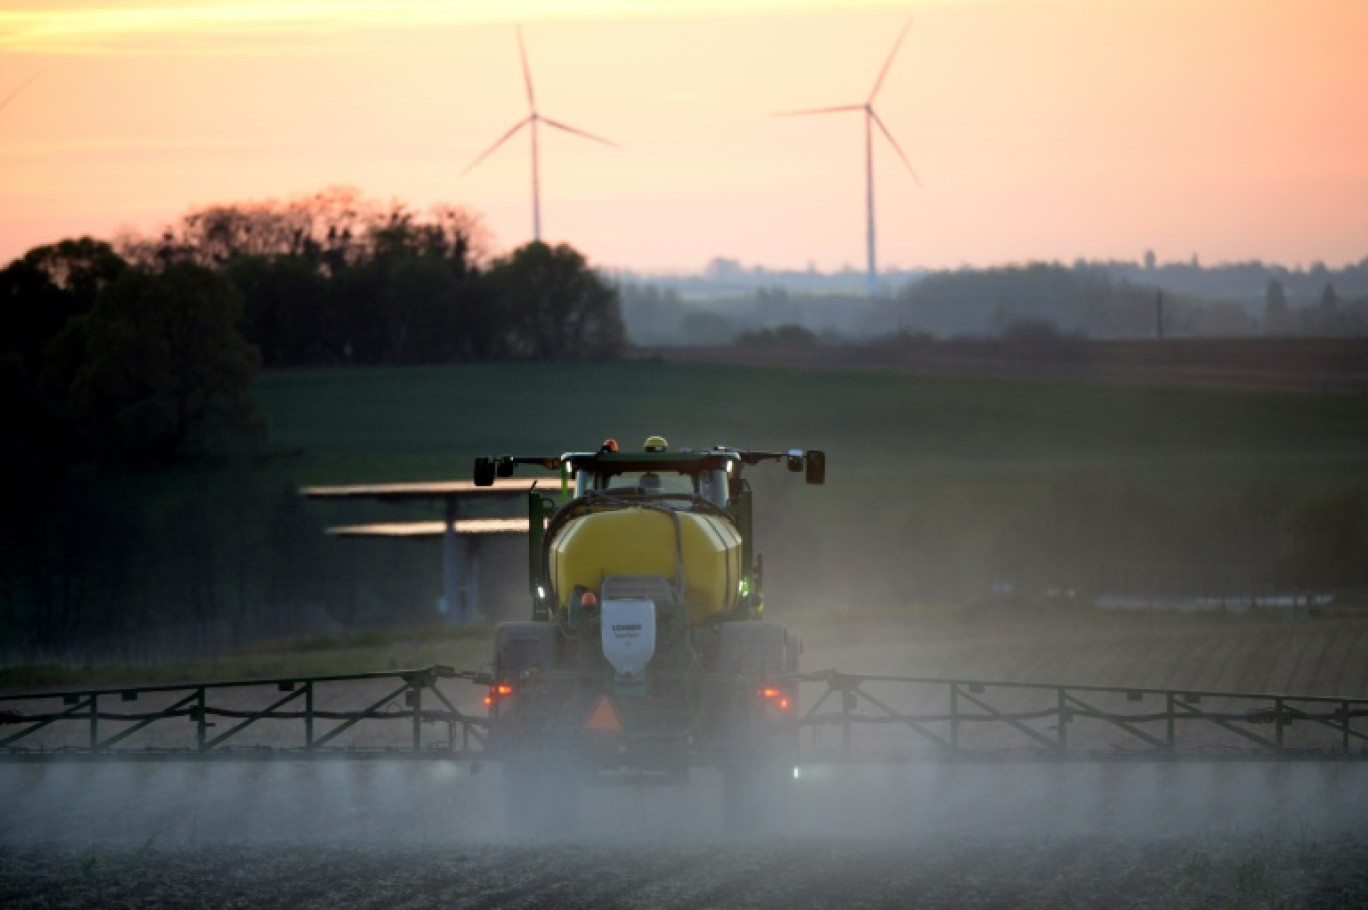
[0,437,1368,827]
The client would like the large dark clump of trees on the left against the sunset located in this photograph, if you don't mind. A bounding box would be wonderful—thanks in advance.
[0,189,625,460]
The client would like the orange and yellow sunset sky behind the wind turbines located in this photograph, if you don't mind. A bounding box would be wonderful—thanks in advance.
[0,0,1368,271]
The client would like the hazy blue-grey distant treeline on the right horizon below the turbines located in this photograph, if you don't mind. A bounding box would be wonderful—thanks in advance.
[621,260,1368,345]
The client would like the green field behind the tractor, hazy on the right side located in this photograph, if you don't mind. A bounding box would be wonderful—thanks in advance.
[256,361,1368,601]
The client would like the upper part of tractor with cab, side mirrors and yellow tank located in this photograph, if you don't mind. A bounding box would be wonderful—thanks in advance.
[475,437,826,627]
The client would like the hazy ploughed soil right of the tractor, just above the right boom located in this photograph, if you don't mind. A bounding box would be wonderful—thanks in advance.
[787,606,1368,698]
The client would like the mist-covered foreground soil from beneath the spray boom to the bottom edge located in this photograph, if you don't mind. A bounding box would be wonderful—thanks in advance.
[0,762,1368,910]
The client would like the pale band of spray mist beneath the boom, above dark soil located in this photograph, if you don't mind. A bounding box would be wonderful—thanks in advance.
[0,759,1368,851]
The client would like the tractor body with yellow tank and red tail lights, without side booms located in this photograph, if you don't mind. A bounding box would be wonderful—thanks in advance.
[475,437,826,831]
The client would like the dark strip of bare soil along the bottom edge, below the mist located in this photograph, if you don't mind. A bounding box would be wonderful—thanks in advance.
[0,836,1368,910]
